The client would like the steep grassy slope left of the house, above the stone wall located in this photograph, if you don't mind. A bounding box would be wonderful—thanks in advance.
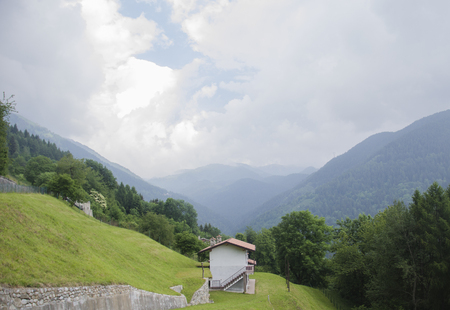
[0,194,207,300]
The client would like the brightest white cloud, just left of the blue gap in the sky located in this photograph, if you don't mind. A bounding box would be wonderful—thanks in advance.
[75,0,179,124]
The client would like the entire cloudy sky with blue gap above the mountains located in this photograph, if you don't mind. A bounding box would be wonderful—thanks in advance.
[0,0,450,178]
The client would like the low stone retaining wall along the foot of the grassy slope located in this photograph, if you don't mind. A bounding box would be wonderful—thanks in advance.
[0,281,209,310]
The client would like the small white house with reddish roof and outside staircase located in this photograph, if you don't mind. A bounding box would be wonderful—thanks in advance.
[198,236,256,293]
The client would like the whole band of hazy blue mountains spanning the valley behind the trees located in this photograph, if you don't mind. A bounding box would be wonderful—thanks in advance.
[11,110,450,234]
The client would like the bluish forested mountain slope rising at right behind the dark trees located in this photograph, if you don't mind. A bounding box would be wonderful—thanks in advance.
[243,111,450,229]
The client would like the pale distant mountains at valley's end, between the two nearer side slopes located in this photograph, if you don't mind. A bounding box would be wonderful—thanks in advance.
[149,164,316,233]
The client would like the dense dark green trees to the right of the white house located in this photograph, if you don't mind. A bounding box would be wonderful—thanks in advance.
[241,182,450,310]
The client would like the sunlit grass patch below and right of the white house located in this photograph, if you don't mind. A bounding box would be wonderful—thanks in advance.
[198,272,335,310]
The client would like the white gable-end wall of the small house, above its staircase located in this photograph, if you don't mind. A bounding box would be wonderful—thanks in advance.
[209,244,248,280]
